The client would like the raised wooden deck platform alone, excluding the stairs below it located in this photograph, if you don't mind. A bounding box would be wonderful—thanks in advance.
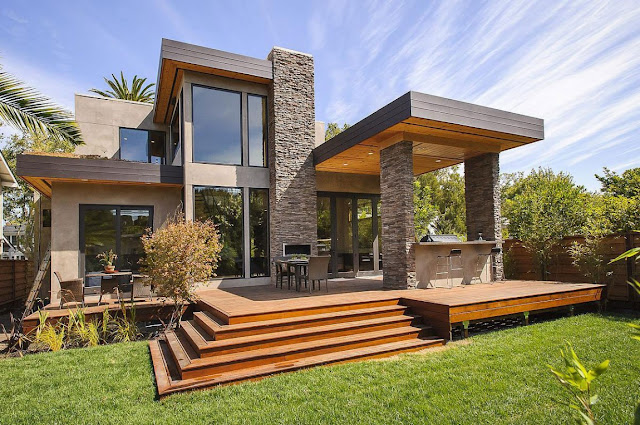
[199,277,605,339]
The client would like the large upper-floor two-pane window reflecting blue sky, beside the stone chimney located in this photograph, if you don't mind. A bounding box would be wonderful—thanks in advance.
[192,85,268,167]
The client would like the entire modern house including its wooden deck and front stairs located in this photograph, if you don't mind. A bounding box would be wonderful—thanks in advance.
[17,40,603,395]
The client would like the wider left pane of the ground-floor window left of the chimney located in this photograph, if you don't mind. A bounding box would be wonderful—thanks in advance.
[194,186,244,277]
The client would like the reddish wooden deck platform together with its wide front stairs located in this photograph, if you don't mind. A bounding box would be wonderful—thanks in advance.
[149,278,604,397]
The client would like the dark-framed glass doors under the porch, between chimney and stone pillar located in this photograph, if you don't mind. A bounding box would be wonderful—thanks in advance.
[317,193,381,277]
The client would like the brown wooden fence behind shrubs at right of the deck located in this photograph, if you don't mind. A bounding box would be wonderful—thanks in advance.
[503,233,640,301]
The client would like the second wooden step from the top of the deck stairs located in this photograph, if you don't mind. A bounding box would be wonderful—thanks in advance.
[193,304,407,341]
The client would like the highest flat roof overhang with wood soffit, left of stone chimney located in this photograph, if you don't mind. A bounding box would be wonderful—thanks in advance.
[158,38,273,124]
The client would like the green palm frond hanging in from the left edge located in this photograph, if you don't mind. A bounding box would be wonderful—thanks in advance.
[0,65,84,145]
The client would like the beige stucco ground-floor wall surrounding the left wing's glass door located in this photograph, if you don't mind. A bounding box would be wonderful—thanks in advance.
[51,182,182,299]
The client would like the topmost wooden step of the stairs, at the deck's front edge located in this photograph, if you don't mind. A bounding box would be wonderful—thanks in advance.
[197,296,400,325]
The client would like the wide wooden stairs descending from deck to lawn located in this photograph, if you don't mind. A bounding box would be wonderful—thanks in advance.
[150,300,444,397]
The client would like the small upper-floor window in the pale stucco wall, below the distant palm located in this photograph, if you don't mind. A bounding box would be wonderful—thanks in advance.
[120,128,165,164]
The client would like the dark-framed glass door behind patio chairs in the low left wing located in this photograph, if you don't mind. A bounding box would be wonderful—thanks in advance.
[80,205,153,273]
